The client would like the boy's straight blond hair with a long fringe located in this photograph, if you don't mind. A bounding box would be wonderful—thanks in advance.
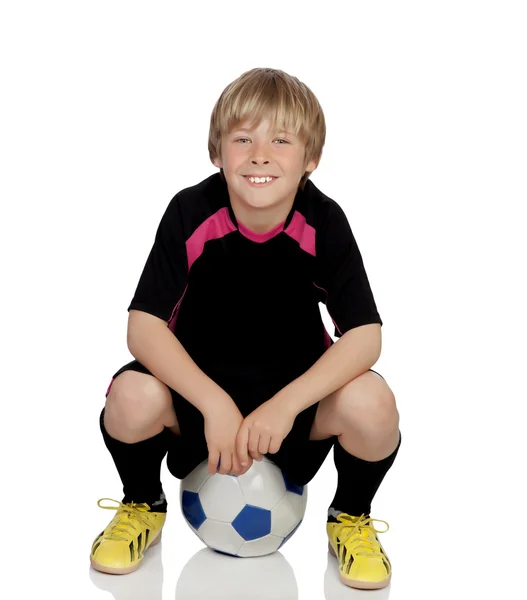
[208,68,326,189]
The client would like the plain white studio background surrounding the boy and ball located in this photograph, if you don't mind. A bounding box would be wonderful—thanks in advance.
[0,0,527,600]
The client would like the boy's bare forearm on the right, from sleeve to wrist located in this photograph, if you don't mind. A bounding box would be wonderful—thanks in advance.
[273,323,382,414]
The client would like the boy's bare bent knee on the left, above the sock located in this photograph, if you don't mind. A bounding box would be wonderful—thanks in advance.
[105,371,172,429]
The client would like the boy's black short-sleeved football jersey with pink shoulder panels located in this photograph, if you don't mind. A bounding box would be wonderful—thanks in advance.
[128,173,382,380]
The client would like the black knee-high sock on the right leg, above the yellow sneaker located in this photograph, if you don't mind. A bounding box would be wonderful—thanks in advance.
[328,432,402,522]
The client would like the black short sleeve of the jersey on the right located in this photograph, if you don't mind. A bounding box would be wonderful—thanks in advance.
[315,201,382,337]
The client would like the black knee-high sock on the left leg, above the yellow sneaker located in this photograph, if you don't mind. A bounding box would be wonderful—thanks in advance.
[99,408,170,512]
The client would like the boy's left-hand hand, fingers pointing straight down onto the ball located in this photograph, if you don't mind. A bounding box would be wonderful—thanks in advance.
[203,398,253,476]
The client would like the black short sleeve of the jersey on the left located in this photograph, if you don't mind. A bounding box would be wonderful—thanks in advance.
[127,196,188,322]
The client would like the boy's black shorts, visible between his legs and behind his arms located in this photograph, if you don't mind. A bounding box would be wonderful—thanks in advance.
[106,360,382,485]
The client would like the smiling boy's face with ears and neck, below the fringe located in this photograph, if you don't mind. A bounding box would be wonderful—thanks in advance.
[213,119,317,228]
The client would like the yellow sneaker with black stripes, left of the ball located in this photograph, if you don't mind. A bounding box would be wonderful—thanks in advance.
[90,498,166,575]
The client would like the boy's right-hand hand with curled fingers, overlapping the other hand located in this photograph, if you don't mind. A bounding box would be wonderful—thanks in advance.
[236,398,297,462]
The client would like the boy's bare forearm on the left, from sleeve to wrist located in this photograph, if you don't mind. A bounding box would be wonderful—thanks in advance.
[127,310,232,414]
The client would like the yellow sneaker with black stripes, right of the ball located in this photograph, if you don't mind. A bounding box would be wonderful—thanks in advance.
[326,513,392,590]
